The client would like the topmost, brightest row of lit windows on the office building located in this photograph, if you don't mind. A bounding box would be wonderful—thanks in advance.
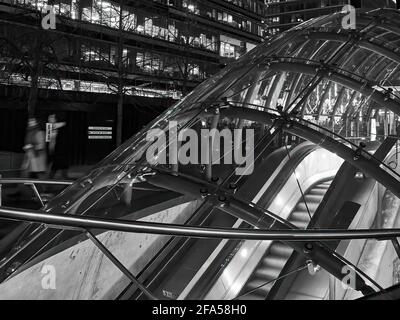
[16,0,256,58]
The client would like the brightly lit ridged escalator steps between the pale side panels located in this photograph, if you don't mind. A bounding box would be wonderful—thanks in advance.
[239,180,332,300]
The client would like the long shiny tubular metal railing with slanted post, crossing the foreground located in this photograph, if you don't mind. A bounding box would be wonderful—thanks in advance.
[0,207,400,299]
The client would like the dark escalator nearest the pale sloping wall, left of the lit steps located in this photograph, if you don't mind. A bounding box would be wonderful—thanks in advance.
[118,143,316,299]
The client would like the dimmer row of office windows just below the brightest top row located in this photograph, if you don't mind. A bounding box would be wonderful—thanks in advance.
[0,20,219,82]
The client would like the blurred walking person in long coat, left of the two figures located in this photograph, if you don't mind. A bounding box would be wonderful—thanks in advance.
[23,118,47,179]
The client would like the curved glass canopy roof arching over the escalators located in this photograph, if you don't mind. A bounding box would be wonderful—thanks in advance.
[0,9,400,300]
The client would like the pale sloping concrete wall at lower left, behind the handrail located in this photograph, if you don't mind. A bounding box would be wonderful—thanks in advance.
[0,201,199,300]
